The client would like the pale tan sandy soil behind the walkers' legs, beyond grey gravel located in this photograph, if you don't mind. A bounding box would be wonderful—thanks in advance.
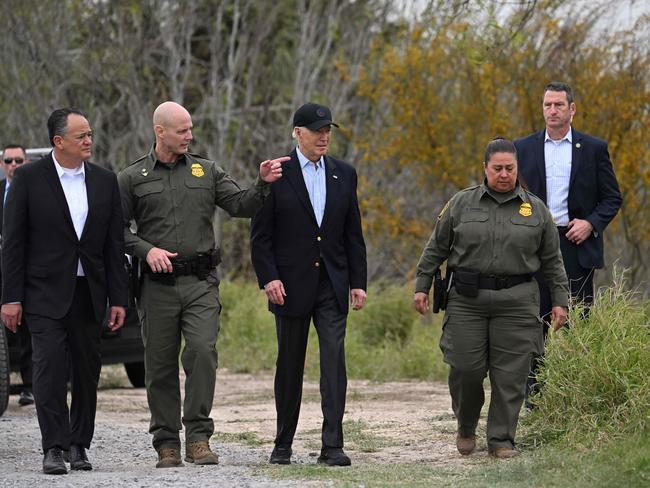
[98,370,486,464]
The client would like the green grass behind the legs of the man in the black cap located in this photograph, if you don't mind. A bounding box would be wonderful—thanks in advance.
[217,281,447,381]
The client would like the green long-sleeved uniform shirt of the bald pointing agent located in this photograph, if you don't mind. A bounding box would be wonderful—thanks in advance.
[118,147,269,260]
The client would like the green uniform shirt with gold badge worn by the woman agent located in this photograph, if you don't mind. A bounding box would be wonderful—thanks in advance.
[415,183,568,307]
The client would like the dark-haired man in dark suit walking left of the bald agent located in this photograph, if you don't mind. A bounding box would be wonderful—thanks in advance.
[2,109,128,474]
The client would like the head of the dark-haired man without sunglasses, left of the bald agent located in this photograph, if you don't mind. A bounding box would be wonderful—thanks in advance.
[47,108,93,164]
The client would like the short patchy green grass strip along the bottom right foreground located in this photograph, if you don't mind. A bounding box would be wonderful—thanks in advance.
[258,436,650,488]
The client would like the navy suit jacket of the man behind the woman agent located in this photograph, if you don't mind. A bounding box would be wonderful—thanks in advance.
[515,129,623,269]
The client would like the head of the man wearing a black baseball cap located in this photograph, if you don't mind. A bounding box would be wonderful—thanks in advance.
[292,103,338,161]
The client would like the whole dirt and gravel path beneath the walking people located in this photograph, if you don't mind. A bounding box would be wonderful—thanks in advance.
[0,366,486,487]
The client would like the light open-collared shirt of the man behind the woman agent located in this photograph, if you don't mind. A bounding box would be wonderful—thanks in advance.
[544,128,573,227]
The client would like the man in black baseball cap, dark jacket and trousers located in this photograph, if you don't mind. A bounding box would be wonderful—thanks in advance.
[251,103,367,466]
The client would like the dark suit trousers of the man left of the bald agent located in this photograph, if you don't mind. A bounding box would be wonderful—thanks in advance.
[27,278,101,451]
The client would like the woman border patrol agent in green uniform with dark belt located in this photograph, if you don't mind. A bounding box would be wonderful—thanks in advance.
[414,139,568,458]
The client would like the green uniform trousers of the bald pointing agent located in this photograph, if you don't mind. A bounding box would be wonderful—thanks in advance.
[138,274,221,450]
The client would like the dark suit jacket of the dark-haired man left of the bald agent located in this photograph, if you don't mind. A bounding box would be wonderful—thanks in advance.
[2,154,128,321]
